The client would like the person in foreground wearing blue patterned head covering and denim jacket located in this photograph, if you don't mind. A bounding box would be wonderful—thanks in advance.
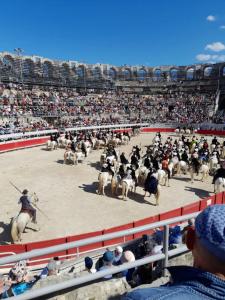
[123,205,225,300]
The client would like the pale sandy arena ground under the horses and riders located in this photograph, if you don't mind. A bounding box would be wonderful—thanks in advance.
[0,134,222,243]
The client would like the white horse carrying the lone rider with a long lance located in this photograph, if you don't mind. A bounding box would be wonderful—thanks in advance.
[11,194,40,243]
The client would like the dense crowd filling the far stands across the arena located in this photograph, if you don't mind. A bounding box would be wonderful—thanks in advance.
[0,84,222,131]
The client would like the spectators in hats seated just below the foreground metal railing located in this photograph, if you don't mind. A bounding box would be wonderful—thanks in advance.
[0,226,185,299]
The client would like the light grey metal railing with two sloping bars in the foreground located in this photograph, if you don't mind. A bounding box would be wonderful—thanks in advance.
[0,212,199,300]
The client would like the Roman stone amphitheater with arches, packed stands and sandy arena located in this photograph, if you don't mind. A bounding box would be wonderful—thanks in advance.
[0,52,225,299]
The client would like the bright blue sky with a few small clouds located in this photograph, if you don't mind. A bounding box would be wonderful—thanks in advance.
[0,0,225,66]
